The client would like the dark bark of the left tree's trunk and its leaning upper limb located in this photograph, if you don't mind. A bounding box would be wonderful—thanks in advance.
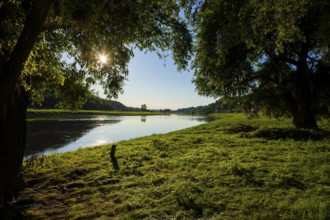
[0,0,54,203]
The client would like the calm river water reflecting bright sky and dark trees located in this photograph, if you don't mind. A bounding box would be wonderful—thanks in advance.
[25,114,211,156]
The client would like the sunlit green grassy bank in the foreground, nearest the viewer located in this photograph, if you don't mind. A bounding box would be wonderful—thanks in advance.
[8,114,330,219]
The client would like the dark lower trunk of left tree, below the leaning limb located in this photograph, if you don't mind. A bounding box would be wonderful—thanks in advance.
[0,88,28,203]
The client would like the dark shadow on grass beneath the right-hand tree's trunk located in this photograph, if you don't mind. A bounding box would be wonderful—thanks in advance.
[252,128,330,141]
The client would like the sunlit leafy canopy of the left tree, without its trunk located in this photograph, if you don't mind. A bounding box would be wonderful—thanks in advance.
[0,0,191,108]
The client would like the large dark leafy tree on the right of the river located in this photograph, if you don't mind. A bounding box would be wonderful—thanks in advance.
[182,0,330,128]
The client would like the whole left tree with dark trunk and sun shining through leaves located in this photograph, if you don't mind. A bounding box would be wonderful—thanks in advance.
[0,0,191,203]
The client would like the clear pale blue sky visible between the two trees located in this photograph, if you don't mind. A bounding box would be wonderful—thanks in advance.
[94,50,215,110]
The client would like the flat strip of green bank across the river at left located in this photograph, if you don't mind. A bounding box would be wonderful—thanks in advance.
[27,108,163,120]
